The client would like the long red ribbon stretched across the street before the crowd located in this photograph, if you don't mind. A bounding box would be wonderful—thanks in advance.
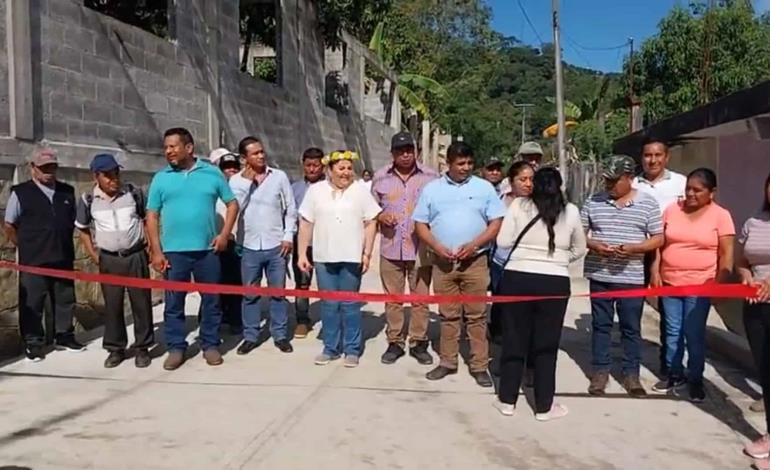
[0,261,757,304]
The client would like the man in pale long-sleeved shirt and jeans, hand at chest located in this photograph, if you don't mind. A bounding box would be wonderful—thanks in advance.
[230,137,297,355]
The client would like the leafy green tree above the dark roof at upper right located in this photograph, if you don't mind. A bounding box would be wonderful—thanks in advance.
[624,0,770,123]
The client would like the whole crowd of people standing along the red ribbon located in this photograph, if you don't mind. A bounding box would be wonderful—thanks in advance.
[5,128,770,468]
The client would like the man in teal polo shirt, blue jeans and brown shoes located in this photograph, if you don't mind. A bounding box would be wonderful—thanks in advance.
[147,127,238,370]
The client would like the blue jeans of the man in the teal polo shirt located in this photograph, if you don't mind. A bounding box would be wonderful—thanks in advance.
[163,251,222,352]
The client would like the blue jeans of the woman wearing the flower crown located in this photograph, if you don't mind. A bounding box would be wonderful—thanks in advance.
[315,263,362,357]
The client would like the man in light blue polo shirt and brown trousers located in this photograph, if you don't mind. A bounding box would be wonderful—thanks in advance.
[412,142,505,387]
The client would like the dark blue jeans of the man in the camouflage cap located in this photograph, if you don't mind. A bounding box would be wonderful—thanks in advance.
[591,280,644,376]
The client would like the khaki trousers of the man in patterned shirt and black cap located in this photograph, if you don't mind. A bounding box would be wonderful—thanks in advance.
[380,257,432,348]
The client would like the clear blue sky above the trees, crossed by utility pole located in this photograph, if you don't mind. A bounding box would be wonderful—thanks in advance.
[487,0,770,72]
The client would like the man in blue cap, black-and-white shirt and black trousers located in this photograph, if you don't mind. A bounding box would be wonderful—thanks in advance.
[75,153,154,368]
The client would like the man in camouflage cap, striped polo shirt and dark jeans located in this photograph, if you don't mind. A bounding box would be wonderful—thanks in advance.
[581,155,663,397]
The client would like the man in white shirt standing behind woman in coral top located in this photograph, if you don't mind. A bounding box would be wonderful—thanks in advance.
[633,138,687,376]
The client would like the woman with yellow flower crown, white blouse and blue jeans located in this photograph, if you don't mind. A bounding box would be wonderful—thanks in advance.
[297,150,381,367]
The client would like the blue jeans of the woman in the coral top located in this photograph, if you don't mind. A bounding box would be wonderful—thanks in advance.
[660,297,711,382]
